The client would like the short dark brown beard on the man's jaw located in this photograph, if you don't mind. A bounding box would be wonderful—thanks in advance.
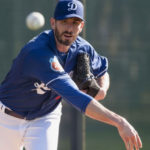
[54,27,76,46]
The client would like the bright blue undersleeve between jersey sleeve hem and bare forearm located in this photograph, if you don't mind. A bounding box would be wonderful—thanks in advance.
[48,75,93,112]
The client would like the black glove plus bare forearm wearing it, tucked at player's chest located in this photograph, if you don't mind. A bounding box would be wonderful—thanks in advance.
[73,53,109,100]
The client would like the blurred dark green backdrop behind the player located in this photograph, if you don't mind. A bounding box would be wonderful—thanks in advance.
[0,0,150,150]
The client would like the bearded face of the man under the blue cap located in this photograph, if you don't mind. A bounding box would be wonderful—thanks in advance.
[51,18,84,46]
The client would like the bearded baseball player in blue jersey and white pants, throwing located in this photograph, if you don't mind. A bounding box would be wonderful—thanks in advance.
[0,0,142,150]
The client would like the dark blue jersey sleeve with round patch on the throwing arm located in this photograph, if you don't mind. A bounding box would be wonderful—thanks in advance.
[23,49,65,84]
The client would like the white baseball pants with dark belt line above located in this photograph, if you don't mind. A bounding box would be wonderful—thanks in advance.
[0,103,62,150]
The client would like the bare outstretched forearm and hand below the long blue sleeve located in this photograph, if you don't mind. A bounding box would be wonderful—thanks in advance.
[85,100,142,150]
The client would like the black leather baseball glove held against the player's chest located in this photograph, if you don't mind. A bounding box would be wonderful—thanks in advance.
[73,53,100,97]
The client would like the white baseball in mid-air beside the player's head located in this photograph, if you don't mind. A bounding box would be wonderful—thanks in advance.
[26,12,45,30]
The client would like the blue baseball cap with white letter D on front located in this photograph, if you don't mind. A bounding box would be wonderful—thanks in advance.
[54,0,84,20]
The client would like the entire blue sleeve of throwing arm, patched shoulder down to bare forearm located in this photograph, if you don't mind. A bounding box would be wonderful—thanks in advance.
[23,51,93,112]
